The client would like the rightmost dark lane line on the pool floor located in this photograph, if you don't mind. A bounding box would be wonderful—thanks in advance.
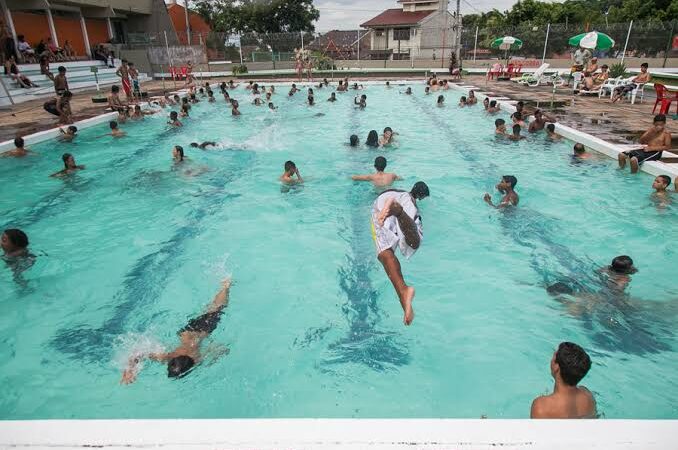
[416,95,672,355]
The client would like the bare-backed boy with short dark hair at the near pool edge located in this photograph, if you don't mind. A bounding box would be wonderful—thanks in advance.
[530,342,597,419]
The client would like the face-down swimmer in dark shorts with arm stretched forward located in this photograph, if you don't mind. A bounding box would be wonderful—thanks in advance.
[120,278,231,384]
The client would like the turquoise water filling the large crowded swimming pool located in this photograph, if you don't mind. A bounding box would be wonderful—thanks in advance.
[0,85,678,419]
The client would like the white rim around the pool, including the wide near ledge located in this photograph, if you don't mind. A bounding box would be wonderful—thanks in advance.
[0,80,678,450]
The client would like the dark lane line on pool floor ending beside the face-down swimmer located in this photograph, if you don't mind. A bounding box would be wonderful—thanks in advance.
[51,142,256,361]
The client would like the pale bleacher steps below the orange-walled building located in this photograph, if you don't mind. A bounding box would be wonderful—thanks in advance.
[0,61,150,106]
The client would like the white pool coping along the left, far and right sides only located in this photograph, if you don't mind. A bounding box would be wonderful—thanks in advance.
[0,80,678,180]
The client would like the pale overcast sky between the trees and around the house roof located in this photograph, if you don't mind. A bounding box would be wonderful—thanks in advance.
[313,0,516,31]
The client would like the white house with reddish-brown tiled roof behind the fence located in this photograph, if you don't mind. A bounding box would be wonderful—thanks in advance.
[360,0,458,59]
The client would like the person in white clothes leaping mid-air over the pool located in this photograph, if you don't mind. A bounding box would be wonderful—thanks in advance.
[372,181,429,325]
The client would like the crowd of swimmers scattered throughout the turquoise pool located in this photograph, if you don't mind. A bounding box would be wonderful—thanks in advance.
[0,77,678,418]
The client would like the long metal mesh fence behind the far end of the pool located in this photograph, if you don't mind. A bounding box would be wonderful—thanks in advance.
[123,21,678,73]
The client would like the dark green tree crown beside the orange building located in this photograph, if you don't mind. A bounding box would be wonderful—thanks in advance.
[196,0,320,33]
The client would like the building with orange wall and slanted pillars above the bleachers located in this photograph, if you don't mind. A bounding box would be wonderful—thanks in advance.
[0,0,176,58]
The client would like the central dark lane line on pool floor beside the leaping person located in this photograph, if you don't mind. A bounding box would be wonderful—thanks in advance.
[323,89,410,372]
